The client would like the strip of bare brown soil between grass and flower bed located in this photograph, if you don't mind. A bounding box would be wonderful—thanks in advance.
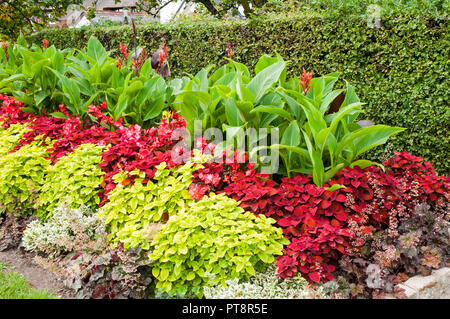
[0,249,75,299]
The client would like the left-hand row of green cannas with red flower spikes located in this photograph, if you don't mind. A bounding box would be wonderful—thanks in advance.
[0,37,173,127]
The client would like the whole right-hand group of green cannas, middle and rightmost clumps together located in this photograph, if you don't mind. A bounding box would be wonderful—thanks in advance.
[173,56,403,186]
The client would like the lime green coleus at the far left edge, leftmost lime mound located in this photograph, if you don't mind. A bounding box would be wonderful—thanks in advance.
[0,135,53,216]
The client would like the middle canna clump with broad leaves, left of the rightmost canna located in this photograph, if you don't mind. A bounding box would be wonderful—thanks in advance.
[171,56,286,149]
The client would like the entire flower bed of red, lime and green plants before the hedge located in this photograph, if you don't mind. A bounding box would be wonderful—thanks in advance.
[0,39,450,298]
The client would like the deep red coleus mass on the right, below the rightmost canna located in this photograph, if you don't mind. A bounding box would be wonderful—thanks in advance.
[224,153,449,282]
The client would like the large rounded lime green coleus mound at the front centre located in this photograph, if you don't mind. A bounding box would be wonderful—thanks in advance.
[150,193,287,297]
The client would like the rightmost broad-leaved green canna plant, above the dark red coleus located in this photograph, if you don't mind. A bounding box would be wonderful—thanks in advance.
[258,73,404,186]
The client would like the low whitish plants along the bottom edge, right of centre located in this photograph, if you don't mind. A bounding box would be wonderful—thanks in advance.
[203,265,325,299]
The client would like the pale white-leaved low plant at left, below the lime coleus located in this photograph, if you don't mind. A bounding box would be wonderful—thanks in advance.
[22,203,106,257]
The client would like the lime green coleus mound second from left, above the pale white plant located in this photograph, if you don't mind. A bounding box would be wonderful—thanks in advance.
[38,143,105,218]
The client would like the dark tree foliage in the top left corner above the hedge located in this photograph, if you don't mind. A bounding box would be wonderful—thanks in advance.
[0,0,83,39]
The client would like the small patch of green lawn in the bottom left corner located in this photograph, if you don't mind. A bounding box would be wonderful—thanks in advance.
[0,262,58,299]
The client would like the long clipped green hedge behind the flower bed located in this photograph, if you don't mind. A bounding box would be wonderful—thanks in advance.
[32,12,450,175]
